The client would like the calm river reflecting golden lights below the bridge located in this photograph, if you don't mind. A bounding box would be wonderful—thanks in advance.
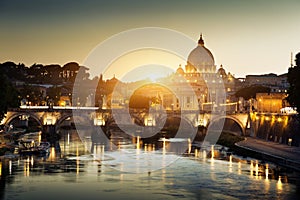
[0,130,299,200]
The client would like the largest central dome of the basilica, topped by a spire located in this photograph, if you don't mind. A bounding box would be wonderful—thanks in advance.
[186,34,216,73]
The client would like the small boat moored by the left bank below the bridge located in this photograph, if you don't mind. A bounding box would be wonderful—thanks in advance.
[18,140,50,156]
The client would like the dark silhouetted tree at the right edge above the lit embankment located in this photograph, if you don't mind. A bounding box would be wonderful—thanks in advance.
[287,52,300,116]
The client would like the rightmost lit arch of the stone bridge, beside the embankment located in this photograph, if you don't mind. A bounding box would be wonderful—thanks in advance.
[207,115,246,135]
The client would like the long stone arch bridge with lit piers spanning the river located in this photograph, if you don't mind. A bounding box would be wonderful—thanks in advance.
[1,107,251,135]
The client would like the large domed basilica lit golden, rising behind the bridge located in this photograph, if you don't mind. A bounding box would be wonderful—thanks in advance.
[162,34,239,111]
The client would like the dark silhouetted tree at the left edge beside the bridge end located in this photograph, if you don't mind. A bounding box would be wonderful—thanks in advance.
[0,71,19,121]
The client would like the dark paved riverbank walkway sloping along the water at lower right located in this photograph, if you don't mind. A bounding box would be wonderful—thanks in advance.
[234,137,300,171]
